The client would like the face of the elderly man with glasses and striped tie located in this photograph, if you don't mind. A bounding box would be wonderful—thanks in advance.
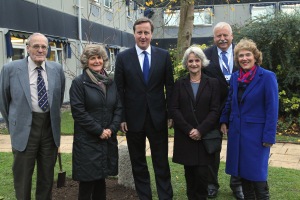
[27,34,48,66]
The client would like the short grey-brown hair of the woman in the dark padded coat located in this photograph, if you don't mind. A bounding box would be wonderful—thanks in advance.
[80,44,109,69]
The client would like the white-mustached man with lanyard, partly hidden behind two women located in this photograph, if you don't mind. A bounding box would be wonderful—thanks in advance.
[204,22,244,199]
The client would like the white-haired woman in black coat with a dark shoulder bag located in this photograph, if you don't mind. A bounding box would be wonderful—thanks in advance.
[170,46,220,200]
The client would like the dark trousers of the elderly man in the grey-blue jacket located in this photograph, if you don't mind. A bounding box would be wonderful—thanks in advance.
[12,113,57,200]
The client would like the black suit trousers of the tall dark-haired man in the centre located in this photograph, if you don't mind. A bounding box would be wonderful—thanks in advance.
[126,113,173,200]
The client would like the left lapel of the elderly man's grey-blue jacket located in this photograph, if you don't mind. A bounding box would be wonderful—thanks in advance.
[18,58,32,108]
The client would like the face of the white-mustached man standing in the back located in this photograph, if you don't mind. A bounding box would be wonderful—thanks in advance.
[214,26,233,51]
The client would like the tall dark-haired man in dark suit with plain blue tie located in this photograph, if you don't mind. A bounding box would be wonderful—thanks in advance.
[115,18,174,200]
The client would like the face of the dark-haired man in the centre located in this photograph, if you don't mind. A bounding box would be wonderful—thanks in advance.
[134,22,152,50]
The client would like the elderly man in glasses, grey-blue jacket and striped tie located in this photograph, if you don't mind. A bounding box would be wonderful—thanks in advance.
[0,33,65,200]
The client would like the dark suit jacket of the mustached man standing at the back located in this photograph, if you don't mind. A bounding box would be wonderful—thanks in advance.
[203,45,238,110]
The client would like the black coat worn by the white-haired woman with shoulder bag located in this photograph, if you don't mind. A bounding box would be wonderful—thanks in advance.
[170,74,220,166]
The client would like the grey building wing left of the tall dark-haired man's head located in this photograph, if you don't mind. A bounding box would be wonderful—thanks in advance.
[0,0,144,105]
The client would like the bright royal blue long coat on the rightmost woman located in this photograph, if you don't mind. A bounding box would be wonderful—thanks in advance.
[220,67,278,181]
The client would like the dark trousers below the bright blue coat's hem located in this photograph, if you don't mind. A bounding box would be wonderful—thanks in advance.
[242,179,270,200]
